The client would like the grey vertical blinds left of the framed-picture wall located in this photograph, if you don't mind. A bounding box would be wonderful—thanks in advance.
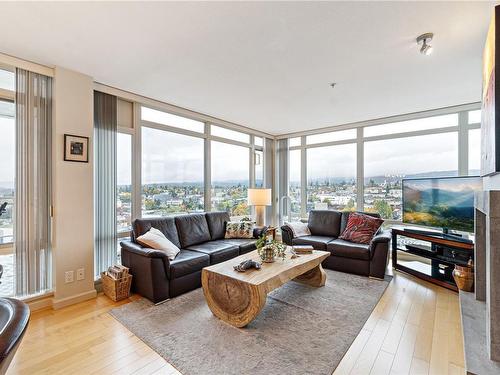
[14,69,52,296]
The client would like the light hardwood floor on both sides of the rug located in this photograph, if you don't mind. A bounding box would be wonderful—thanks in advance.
[7,273,465,375]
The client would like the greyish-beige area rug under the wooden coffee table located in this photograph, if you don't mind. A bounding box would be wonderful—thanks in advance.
[111,270,391,375]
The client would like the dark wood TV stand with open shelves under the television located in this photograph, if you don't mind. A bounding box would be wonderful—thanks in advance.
[392,229,474,291]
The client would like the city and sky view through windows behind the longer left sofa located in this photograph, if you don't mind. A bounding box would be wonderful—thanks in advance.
[117,123,258,232]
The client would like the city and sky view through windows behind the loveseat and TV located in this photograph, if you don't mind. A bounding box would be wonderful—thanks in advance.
[289,111,480,221]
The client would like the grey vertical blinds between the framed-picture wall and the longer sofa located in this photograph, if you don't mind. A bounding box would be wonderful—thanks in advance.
[94,91,117,275]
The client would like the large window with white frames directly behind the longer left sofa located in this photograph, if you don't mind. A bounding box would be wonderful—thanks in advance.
[133,105,270,223]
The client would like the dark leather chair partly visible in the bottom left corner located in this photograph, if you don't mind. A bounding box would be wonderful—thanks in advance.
[0,298,30,374]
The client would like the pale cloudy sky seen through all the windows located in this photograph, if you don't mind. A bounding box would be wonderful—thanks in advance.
[0,102,480,187]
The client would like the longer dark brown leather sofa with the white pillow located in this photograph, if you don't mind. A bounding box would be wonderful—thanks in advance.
[120,212,265,303]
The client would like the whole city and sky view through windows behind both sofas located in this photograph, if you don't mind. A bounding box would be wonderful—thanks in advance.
[117,111,480,231]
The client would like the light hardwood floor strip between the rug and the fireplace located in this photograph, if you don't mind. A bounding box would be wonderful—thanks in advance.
[334,272,465,375]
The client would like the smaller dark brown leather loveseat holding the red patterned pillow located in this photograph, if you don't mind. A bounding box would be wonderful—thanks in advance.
[281,210,391,279]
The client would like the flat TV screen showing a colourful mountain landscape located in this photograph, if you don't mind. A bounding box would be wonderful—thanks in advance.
[403,177,482,232]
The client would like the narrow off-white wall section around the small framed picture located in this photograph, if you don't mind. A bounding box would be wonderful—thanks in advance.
[52,67,96,308]
